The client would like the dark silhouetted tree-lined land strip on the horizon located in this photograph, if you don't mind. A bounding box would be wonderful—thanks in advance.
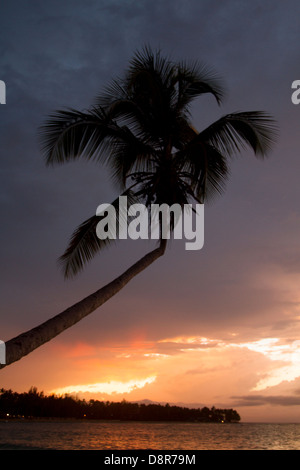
[0,387,240,423]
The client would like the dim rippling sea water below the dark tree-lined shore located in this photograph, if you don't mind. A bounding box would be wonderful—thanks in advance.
[0,421,300,450]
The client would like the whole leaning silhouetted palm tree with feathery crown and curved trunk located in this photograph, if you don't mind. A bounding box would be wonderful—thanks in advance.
[0,48,275,370]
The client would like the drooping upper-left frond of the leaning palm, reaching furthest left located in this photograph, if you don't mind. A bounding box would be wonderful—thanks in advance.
[40,105,156,179]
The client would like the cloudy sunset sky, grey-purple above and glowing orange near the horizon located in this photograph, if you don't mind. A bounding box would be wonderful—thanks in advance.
[0,0,300,422]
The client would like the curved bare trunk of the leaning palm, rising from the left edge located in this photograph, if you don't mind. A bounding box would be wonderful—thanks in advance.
[0,240,166,368]
